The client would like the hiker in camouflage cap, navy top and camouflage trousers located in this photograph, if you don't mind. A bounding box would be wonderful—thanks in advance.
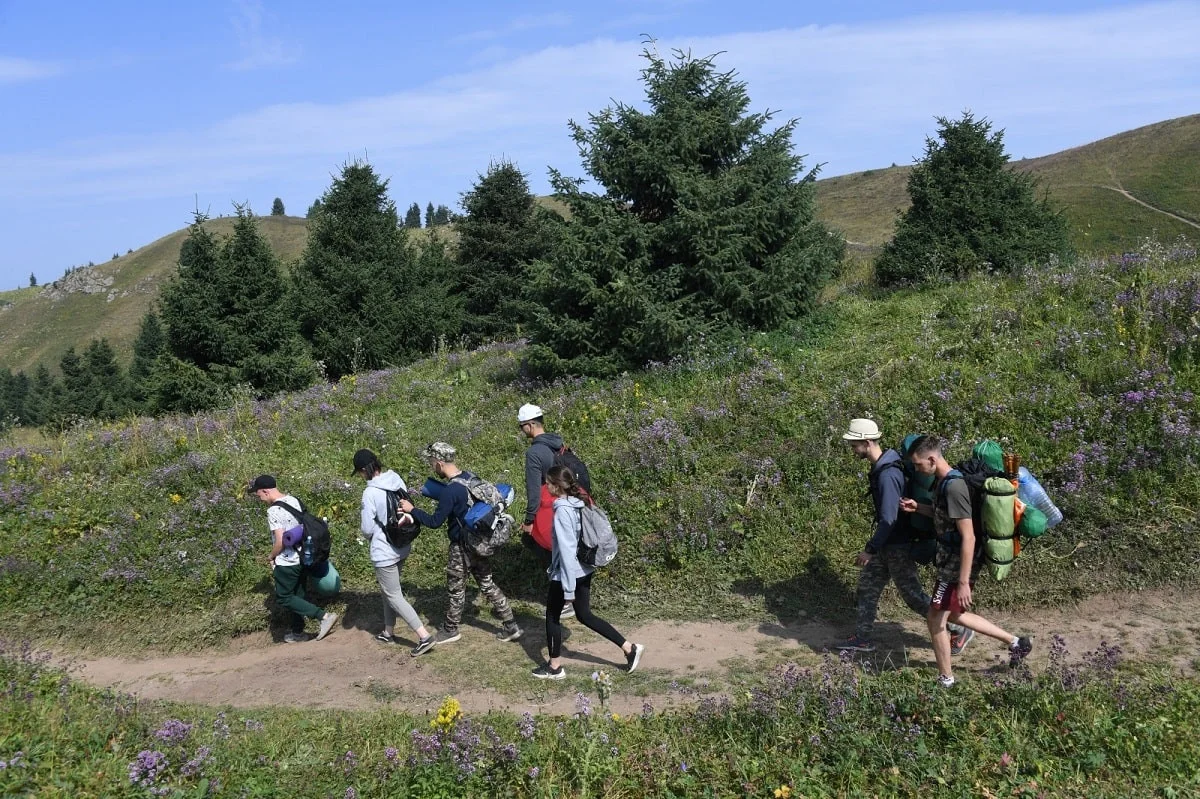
[400,441,522,645]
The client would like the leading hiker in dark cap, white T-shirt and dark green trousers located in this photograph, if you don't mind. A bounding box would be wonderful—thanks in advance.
[246,474,337,643]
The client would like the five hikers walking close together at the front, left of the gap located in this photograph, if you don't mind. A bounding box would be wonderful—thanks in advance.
[247,404,644,680]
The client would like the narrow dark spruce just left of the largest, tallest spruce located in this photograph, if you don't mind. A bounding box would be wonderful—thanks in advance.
[455,161,563,341]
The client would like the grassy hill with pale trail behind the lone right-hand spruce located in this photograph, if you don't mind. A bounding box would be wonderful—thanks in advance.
[817,114,1200,252]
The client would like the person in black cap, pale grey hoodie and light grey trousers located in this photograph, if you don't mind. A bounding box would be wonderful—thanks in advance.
[352,450,433,657]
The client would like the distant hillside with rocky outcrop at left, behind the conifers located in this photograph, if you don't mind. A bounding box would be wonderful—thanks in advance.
[0,216,307,372]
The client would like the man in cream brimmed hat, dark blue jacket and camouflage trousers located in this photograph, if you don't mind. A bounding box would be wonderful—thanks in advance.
[838,419,974,655]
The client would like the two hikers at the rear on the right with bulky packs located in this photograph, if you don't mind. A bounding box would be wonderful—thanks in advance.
[839,419,1062,687]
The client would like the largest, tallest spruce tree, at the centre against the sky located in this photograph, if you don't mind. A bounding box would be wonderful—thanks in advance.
[530,50,845,374]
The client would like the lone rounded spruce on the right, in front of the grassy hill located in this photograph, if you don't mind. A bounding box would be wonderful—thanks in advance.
[875,112,1069,286]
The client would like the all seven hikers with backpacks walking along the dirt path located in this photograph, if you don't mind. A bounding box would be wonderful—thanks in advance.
[247,404,1062,687]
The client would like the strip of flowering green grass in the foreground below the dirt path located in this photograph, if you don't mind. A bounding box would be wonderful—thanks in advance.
[0,633,1200,799]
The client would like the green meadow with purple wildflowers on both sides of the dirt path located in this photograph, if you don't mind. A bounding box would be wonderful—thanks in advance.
[0,235,1200,798]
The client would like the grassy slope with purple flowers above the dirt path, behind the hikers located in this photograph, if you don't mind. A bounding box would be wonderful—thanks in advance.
[0,237,1200,651]
